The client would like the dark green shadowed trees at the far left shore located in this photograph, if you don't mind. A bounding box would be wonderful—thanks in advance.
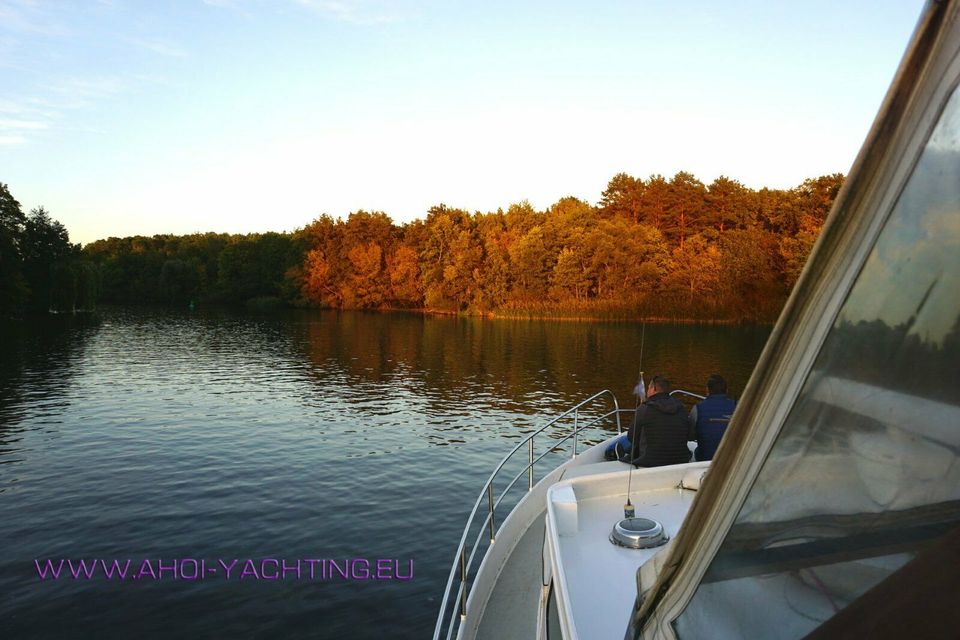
[0,183,98,317]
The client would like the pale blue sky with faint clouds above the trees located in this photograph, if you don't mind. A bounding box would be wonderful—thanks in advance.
[0,0,923,243]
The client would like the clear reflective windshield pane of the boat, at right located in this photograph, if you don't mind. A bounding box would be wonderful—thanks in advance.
[674,82,960,638]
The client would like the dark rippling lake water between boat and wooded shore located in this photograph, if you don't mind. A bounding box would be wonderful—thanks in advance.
[0,309,769,638]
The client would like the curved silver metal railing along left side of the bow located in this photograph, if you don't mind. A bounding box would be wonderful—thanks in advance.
[433,390,633,640]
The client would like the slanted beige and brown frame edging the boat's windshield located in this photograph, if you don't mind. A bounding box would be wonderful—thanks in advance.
[628,0,960,639]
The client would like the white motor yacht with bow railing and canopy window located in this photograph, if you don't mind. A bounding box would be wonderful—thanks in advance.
[434,0,960,640]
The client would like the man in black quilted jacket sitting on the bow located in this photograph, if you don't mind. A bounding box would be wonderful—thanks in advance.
[629,376,690,467]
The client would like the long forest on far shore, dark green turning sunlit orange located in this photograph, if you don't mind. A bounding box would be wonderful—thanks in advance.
[1,172,843,320]
